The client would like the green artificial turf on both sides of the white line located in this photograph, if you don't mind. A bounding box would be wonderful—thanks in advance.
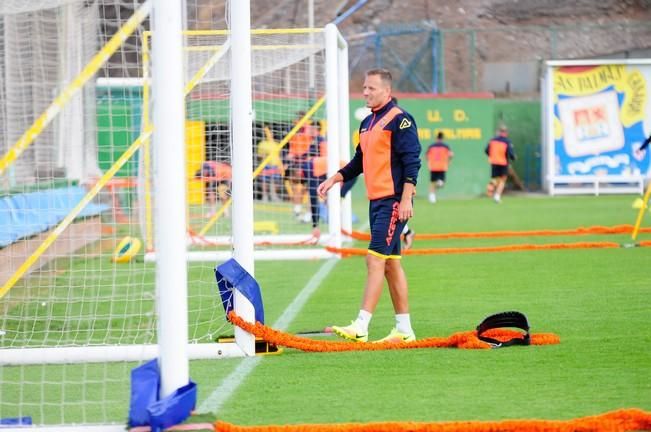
[0,194,651,425]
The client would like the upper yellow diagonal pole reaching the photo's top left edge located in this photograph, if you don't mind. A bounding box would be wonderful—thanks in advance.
[0,0,151,175]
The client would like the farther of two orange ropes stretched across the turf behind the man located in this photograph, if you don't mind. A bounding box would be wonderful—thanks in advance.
[342,225,651,240]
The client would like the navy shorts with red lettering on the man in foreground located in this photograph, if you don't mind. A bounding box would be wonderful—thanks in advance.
[368,197,407,259]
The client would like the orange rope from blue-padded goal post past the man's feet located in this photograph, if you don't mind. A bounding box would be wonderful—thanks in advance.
[228,312,560,352]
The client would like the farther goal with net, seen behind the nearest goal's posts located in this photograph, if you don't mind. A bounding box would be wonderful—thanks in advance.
[138,29,350,262]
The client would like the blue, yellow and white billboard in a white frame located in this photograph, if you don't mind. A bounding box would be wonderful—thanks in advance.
[541,59,651,195]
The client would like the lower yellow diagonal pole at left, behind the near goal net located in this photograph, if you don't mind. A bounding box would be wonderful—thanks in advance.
[0,129,151,298]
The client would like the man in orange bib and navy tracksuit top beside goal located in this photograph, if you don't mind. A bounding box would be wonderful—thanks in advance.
[318,69,420,342]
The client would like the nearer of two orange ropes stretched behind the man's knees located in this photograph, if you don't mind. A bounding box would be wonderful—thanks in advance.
[326,241,651,257]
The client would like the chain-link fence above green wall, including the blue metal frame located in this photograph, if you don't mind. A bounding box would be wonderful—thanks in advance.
[349,21,651,97]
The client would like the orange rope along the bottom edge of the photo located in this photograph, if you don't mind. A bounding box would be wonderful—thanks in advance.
[215,408,651,432]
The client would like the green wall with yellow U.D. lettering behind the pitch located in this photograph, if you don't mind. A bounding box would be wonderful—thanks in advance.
[97,89,540,198]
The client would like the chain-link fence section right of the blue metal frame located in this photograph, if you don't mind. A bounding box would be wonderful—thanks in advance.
[438,22,651,95]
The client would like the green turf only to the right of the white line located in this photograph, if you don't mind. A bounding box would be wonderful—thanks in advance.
[195,196,651,425]
